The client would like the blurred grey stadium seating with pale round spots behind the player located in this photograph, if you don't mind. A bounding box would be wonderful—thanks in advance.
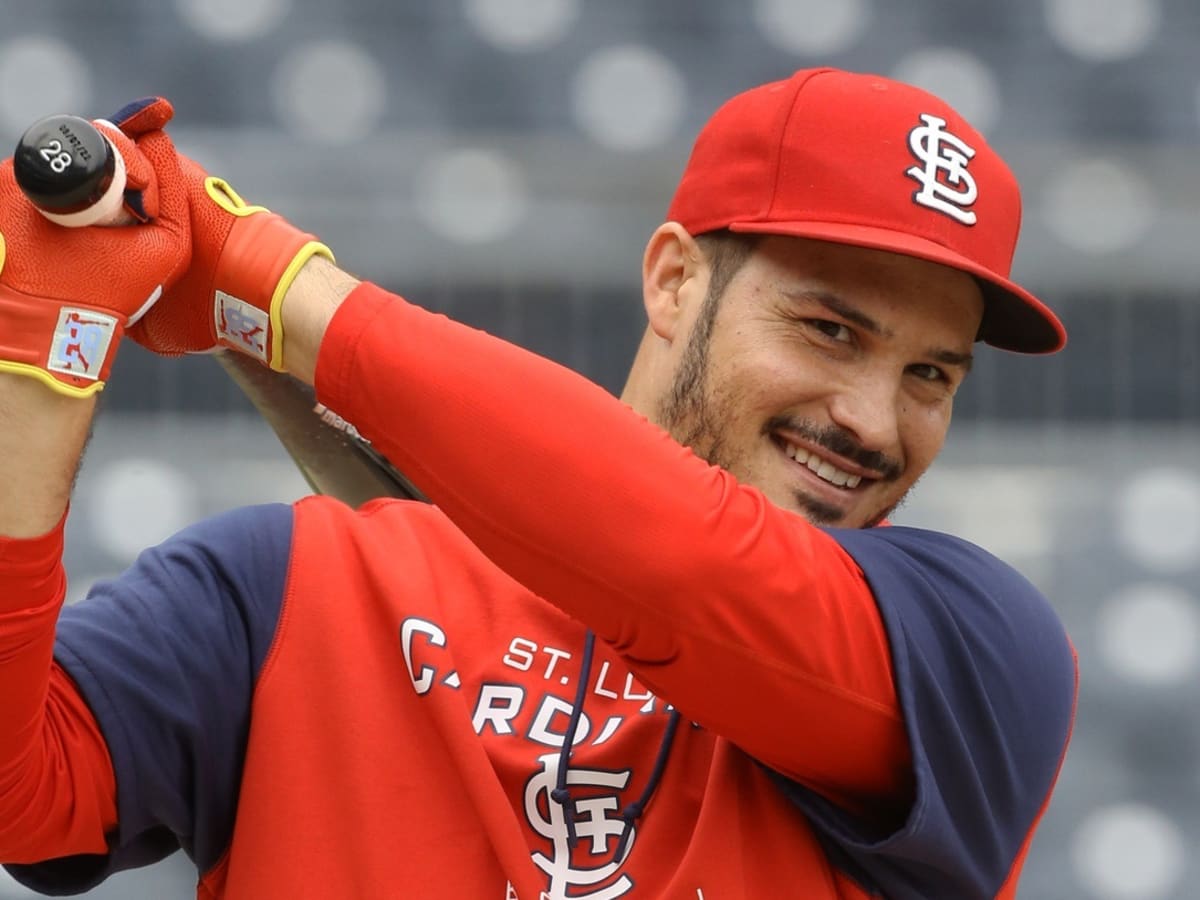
[0,0,1200,900]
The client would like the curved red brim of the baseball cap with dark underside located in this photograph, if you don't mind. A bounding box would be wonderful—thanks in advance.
[727,222,1067,353]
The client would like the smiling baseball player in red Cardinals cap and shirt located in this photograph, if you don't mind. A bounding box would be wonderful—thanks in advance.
[0,70,1076,900]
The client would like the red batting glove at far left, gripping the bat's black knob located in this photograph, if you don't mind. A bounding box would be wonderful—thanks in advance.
[0,101,191,397]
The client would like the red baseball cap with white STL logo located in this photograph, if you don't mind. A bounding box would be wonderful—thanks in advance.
[667,68,1067,353]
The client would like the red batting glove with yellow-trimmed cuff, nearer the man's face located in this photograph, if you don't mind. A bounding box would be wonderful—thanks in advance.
[130,127,334,372]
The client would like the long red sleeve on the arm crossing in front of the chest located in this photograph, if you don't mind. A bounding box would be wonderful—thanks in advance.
[316,284,910,806]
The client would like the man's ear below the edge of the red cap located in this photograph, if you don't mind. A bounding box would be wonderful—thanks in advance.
[642,222,708,341]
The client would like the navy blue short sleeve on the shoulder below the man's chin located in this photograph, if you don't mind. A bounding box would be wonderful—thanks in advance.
[780,527,1076,900]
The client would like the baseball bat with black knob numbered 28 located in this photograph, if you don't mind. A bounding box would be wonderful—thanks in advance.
[13,115,425,506]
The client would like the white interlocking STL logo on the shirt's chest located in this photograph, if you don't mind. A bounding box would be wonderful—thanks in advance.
[524,754,637,900]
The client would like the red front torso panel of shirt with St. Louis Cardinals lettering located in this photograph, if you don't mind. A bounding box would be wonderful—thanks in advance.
[198,498,883,900]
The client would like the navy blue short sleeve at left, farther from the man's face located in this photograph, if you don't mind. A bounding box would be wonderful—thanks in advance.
[8,504,292,894]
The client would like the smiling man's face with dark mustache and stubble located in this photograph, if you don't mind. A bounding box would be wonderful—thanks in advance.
[654,236,983,528]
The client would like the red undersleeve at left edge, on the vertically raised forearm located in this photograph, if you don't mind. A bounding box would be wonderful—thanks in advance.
[0,520,116,863]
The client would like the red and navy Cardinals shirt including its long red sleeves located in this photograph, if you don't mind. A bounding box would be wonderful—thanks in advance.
[0,280,1075,900]
